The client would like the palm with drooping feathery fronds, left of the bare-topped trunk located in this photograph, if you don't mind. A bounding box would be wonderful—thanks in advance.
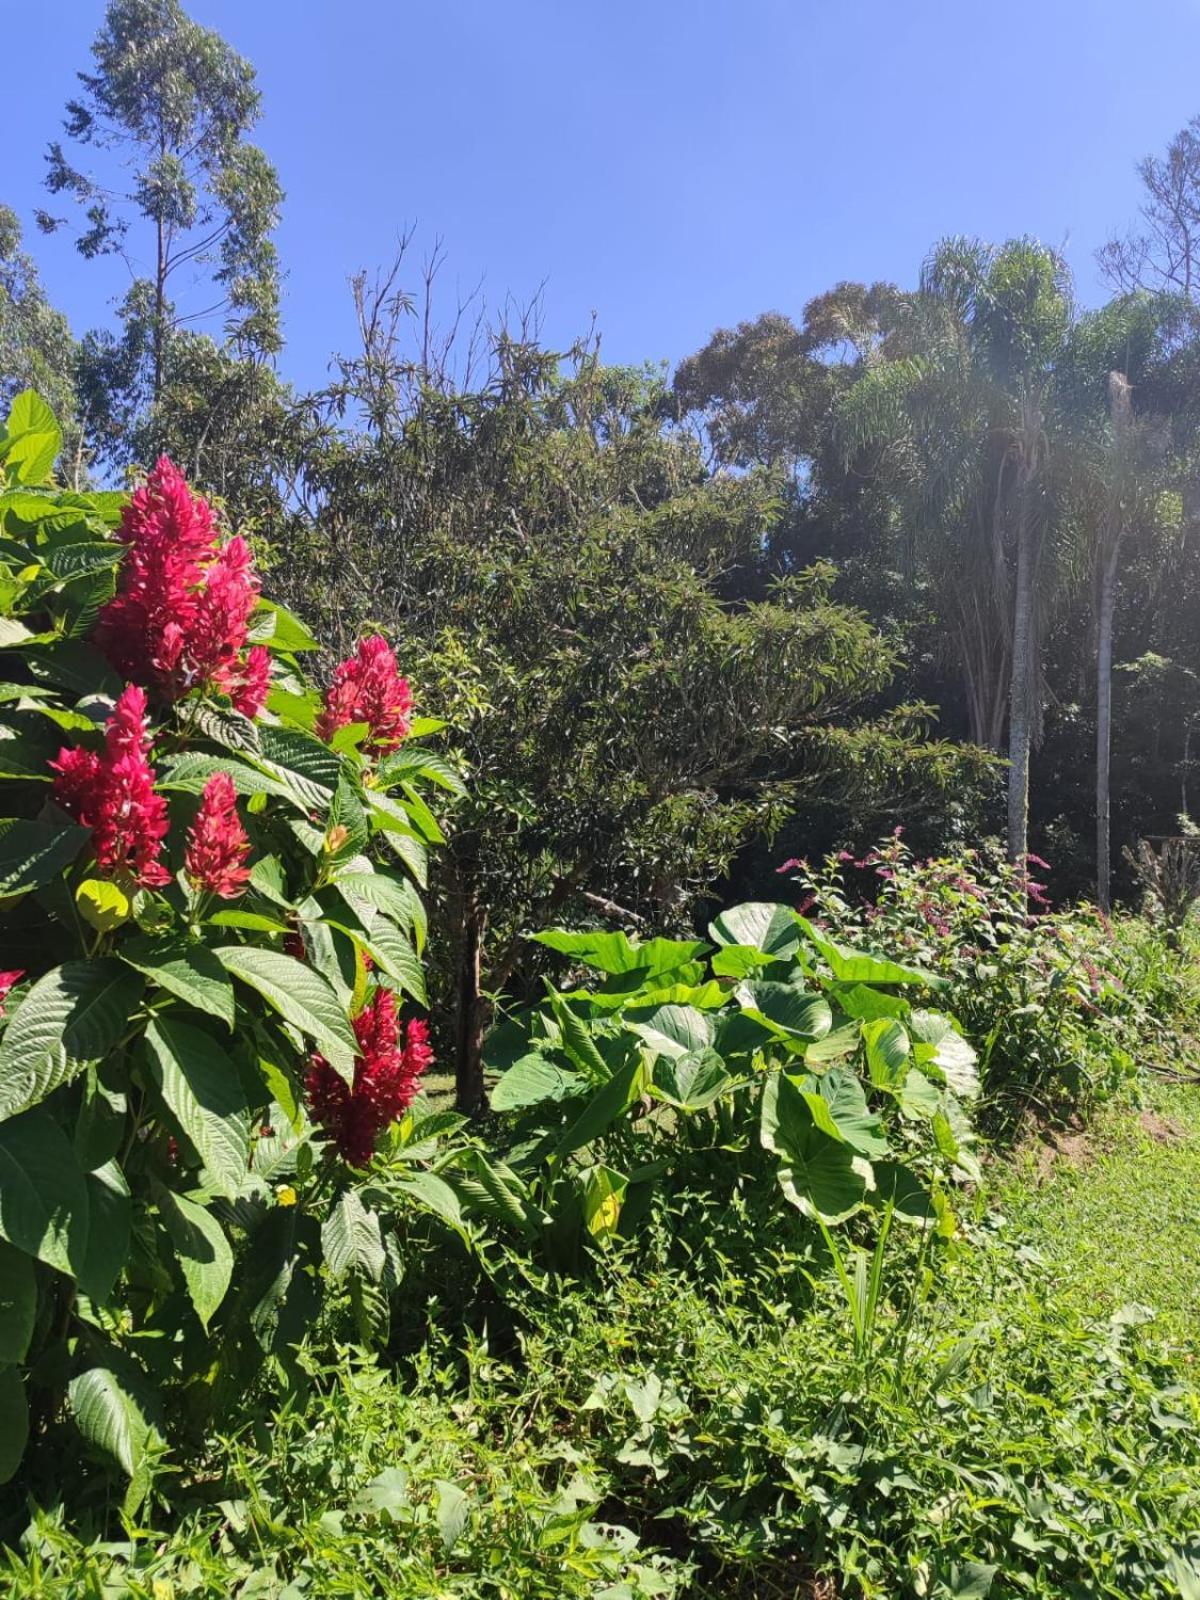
[837,238,1072,859]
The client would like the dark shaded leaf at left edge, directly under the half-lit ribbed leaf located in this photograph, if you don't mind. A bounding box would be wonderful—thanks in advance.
[0,1106,88,1277]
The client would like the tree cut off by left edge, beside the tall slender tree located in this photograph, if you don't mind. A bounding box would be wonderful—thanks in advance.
[0,206,83,485]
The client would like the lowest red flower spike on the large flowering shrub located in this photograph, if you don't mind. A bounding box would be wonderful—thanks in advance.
[307,987,434,1166]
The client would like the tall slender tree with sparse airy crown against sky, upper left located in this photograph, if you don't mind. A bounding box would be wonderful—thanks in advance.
[38,0,282,453]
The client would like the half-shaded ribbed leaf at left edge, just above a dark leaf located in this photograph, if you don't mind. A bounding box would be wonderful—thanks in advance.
[0,958,144,1120]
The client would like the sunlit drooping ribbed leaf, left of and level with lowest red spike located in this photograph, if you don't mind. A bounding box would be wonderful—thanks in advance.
[146,1017,251,1200]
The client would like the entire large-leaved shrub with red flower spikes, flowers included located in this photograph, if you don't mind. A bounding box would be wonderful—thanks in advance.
[0,394,461,1501]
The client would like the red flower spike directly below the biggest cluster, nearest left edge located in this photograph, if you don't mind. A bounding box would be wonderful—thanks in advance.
[50,683,171,888]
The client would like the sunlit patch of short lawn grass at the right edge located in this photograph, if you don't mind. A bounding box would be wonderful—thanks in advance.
[995,1083,1200,1357]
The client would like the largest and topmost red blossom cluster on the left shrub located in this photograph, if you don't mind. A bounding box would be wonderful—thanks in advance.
[96,456,270,717]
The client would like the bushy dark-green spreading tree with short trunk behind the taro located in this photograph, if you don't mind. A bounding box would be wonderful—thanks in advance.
[275,284,998,1109]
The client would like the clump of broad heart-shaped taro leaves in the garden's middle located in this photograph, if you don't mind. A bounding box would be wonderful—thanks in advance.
[490,904,978,1261]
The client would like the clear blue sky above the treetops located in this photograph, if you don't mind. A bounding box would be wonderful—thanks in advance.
[0,0,1200,384]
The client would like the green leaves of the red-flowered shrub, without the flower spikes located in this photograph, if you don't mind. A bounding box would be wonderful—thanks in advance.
[0,394,458,1507]
